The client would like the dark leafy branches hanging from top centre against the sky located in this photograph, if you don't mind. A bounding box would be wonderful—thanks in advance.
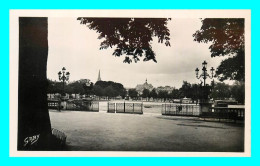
[77,17,170,63]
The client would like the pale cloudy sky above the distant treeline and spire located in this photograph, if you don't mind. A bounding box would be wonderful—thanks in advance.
[47,17,223,88]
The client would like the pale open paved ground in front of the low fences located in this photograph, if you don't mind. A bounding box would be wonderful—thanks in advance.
[50,110,244,152]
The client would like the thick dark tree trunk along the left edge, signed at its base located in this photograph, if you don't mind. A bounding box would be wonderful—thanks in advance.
[18,17,51,150]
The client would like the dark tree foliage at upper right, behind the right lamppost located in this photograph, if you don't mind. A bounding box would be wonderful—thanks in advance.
[193,18,245,81]
